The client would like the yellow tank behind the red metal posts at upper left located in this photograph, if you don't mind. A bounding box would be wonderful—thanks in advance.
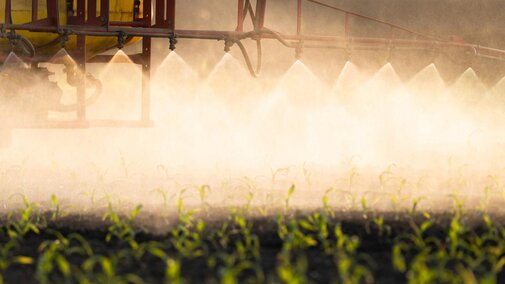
[0,0,139,58]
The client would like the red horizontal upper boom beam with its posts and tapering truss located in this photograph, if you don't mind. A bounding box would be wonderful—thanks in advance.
[0,0,505,53]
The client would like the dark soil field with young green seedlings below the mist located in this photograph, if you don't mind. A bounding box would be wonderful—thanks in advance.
[0,186,505,283]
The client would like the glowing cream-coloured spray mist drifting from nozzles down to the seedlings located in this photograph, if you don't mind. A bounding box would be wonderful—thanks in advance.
[0,1,505,231]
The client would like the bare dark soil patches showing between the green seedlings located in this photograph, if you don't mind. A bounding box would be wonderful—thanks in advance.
[0,212,505,283]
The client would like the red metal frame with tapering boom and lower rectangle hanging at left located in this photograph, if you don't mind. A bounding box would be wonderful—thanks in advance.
[0,0,505,132]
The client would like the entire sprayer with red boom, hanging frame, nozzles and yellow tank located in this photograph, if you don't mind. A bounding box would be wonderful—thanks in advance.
[0,0,505,146]
